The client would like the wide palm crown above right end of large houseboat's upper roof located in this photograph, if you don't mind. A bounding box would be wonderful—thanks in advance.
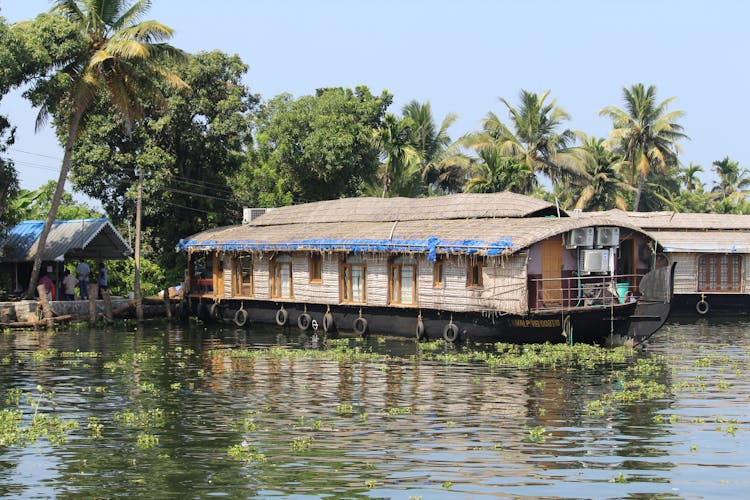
[464,90,588,187]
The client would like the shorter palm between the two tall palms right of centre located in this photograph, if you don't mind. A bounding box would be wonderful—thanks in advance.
[566,135,630,211]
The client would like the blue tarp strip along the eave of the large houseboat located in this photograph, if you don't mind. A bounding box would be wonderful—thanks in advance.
[177,236,513,262]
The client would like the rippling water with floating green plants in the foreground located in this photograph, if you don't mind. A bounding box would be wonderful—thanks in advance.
[0,319,750,499]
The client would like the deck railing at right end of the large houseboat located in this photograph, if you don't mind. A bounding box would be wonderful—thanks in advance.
[529,274,641,312]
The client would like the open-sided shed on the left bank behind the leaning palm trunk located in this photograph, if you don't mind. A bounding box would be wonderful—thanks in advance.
[0,218,133,293]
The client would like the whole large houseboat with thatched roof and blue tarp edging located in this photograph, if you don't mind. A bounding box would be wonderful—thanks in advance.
[177,193,671,343]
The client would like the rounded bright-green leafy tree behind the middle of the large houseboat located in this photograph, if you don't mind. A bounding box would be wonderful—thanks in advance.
[250,86,392,201]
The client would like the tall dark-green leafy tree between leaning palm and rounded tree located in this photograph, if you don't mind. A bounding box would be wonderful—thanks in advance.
[72,51,257,269]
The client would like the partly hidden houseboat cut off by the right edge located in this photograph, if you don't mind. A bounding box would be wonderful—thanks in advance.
[602,210,750,316]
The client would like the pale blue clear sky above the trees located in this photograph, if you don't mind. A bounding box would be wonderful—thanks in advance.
[0,0,750,201]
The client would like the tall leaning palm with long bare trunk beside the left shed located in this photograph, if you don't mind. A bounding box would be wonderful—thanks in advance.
[27,0,187,296]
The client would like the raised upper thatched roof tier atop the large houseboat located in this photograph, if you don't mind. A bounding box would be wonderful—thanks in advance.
[250,192,567,226]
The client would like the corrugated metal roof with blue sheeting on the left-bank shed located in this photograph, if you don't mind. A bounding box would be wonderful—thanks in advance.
[0,219,133,262]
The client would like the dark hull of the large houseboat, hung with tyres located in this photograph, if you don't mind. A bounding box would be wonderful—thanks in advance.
[191,298,636,344]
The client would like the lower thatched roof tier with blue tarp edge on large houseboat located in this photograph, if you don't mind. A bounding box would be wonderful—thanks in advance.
[178,216,642,257]
